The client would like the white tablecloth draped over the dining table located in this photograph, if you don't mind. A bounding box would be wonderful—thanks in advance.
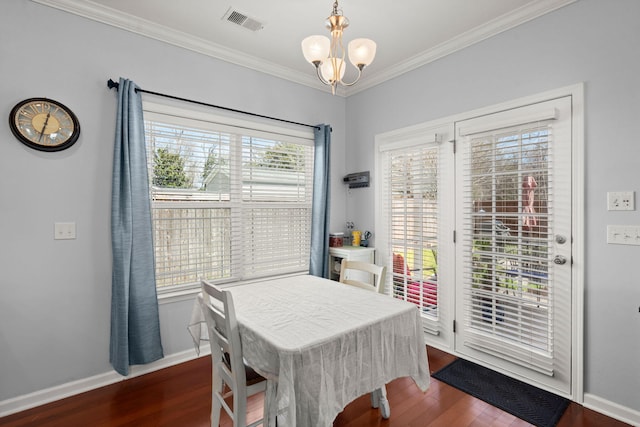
[190,276,430,427]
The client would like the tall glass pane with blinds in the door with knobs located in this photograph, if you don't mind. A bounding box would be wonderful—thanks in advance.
[466,124,552,352]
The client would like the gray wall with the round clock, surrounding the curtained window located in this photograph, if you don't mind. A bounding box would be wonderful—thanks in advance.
[0,0,345,402]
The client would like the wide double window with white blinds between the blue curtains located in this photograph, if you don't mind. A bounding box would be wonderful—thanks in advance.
[145,104,313,291]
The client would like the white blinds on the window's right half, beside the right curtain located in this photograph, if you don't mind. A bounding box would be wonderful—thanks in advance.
[242,137,313,277]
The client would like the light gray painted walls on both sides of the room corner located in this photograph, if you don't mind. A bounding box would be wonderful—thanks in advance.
[0,0,640,422]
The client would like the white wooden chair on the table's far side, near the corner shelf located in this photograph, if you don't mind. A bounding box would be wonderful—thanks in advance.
[340,259,391,419]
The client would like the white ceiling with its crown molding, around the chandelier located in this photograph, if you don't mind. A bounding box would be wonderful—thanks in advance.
[33,0,576,95]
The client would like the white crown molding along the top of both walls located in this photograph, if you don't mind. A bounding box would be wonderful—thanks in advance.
[31,0,577,97]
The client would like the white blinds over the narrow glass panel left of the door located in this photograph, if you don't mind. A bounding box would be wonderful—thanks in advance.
[380,142,442,335]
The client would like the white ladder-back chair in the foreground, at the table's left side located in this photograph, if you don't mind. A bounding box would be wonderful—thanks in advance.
[198,281,271,427]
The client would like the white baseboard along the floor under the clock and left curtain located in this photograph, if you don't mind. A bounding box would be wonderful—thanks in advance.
[0,343,210,417]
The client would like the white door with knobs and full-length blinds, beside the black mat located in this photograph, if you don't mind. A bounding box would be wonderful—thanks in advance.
[454,96,573,395]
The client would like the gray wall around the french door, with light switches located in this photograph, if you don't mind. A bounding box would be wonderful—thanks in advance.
[346,0,640,411]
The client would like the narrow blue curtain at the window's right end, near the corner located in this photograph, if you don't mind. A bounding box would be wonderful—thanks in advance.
[309,125,331,277]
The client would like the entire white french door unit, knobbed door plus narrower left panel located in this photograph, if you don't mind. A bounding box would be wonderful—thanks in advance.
[375,87,583,401]
